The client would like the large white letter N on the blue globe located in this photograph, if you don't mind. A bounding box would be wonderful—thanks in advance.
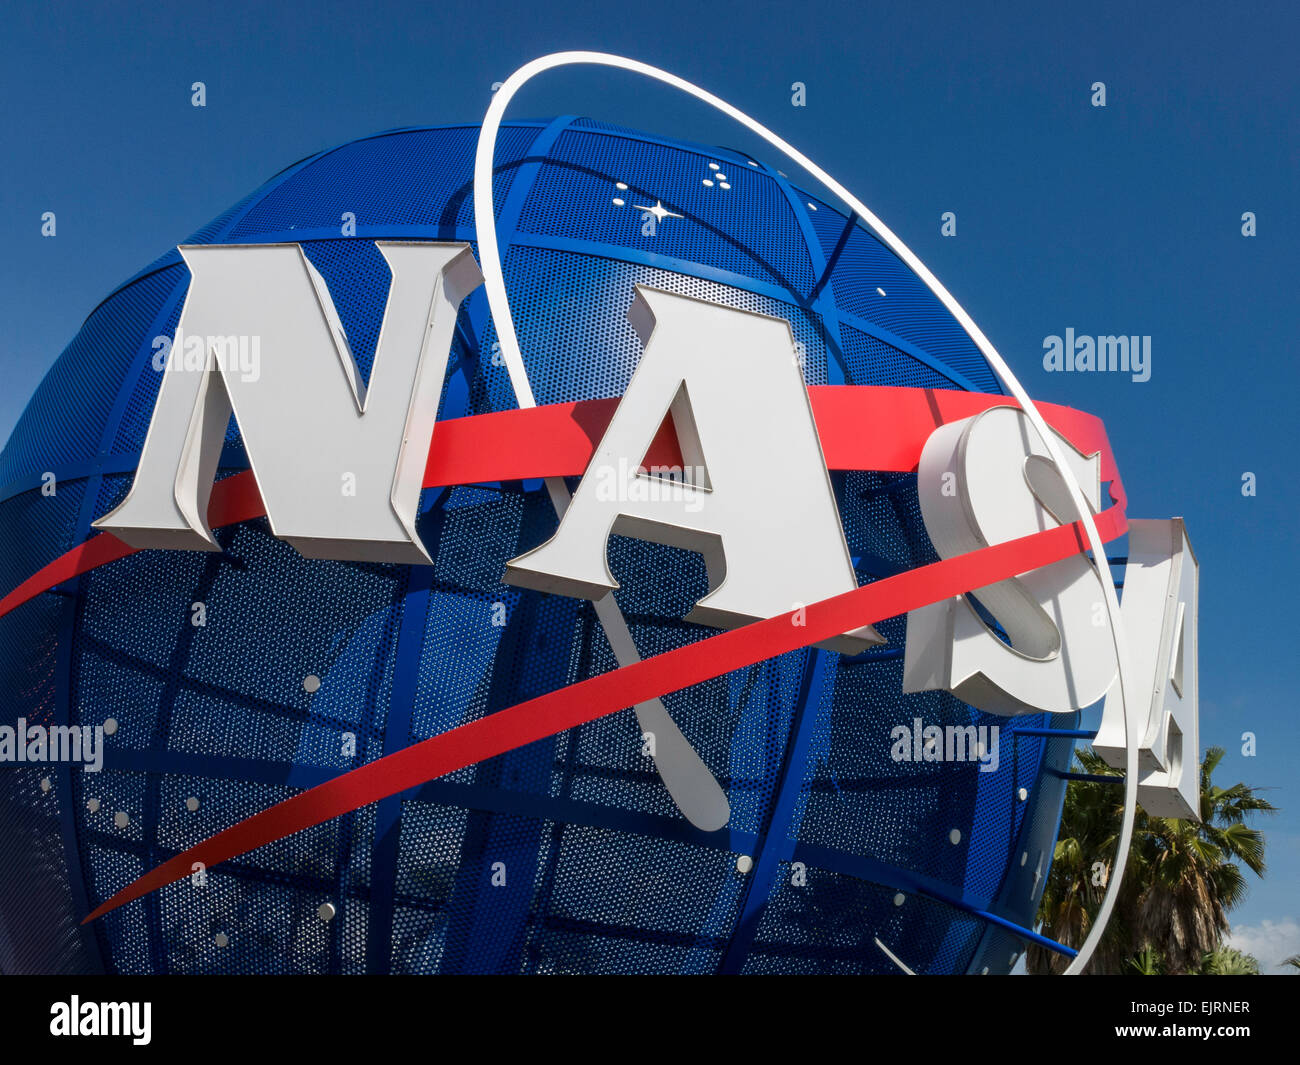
[95,241,482,563]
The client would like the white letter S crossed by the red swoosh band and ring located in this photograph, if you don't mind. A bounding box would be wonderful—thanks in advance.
[904,407,1115,715]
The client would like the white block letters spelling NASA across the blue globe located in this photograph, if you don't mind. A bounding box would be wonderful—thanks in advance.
[95,242,1196,775]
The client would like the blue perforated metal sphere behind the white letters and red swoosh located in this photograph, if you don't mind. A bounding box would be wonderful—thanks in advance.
[0,117,1071,973]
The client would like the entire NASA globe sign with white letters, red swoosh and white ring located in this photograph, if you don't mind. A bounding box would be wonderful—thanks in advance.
[0,53,1199,971]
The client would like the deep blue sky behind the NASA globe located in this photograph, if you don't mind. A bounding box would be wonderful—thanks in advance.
[0,0,1300,962]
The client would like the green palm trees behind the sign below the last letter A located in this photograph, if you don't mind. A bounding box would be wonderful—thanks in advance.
[1026,748,1275,974]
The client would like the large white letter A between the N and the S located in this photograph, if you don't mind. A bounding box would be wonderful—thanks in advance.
[503,285,885,654]
